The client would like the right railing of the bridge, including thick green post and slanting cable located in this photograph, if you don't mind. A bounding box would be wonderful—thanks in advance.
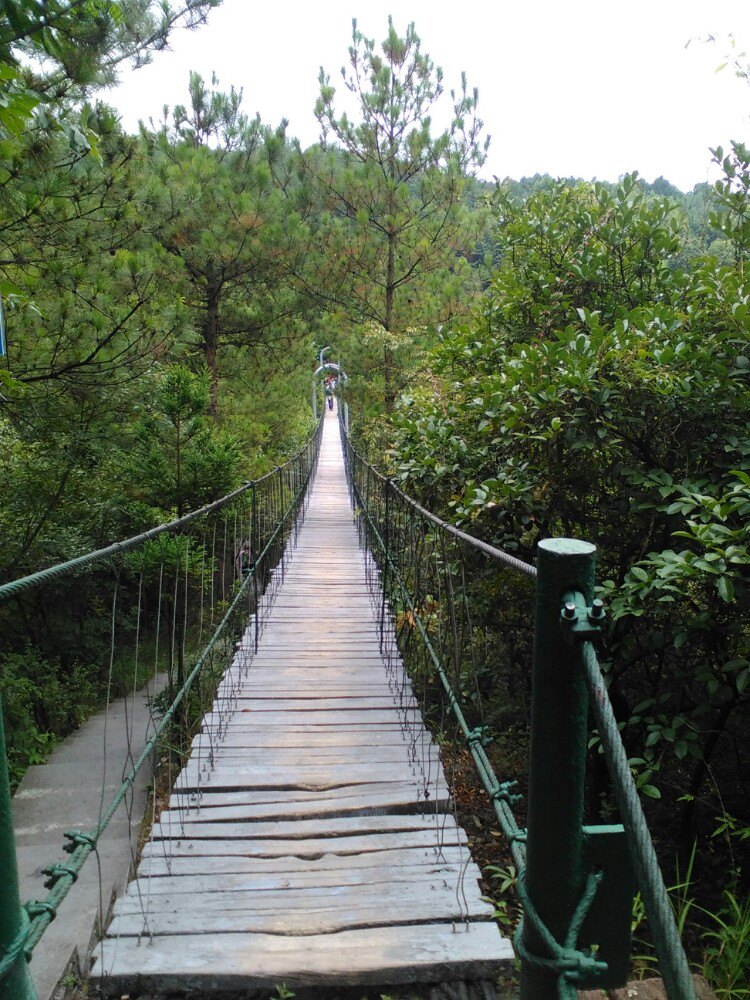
[340,422,695,1000]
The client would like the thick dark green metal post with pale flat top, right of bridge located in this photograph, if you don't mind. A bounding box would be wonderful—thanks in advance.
[521,538,596,1000]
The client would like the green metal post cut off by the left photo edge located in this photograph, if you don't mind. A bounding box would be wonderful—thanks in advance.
[0,699,36,1000]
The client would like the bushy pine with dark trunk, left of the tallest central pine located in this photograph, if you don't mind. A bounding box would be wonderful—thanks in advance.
[141,73,307,417]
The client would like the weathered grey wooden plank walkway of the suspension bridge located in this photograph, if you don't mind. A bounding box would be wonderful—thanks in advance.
[93,414,512,996]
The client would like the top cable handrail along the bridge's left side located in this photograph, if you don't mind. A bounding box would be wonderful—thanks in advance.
[0,418,322,604]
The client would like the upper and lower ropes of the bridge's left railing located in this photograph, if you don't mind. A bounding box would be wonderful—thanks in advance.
[0,420,323,1000]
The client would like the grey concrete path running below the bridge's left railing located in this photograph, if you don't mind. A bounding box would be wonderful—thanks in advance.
[13,677,165,1000]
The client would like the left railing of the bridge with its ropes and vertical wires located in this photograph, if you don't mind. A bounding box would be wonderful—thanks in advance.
[0,419,323,1000]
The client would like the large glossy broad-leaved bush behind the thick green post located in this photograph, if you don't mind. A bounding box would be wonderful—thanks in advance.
[386,164,750,892]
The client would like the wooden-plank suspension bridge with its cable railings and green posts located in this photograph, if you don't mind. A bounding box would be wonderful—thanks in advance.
[0,398,695,1000]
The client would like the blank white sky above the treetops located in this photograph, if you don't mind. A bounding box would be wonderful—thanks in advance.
[106,0,750,190]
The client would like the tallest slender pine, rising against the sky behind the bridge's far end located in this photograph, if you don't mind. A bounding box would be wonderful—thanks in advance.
[305,18,487,408]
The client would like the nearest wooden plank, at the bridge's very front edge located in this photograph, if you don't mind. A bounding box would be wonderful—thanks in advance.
[92,922,513,996]
